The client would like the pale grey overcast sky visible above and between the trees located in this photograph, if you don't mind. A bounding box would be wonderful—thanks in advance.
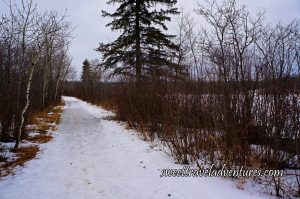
[0,0,300,73]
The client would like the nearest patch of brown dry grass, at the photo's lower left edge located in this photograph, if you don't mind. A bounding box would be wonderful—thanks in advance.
[0,146,39,177]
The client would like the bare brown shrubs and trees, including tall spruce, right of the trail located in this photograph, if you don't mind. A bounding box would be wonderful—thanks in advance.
[67,0,300,198]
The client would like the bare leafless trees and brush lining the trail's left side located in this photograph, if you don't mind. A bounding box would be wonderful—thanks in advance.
[0,0,71,148]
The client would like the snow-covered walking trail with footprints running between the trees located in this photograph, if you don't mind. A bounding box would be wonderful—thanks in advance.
[0,97,268,199]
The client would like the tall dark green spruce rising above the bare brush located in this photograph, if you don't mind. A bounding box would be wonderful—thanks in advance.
[97,0,179,81]
